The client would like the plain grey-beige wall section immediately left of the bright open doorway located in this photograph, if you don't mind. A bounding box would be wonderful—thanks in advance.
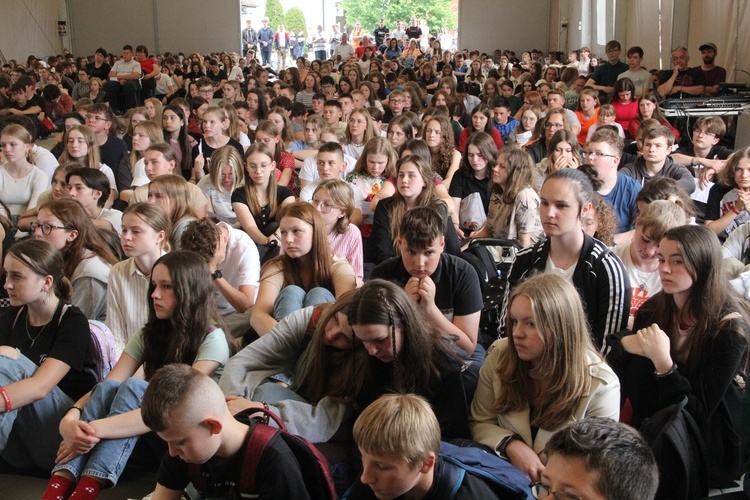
[68,0,240,54]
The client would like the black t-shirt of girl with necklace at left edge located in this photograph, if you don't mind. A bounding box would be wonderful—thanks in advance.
[0,301,96,401]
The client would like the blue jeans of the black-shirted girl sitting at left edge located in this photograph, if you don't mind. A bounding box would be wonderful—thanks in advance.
[0,352,75,471]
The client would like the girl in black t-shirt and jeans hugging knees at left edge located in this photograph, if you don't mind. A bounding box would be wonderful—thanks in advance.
[0,239,96,471]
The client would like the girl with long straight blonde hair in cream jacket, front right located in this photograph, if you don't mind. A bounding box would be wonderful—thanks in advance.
[470,274,620,481]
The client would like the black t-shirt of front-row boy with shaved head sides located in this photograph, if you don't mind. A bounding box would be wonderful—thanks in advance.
[156,424,310,500]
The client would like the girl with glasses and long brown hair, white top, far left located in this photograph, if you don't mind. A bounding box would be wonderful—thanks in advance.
[31,200,118,321]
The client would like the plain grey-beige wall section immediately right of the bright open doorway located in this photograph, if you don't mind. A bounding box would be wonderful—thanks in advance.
[458,0,550,53]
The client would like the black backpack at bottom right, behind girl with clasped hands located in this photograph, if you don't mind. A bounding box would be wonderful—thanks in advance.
[640,396,708,500]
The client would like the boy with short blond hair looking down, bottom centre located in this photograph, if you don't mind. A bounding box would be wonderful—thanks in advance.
[343,394,497,500]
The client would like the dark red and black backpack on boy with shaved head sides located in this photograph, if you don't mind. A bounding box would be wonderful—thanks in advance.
[188,408,338,500]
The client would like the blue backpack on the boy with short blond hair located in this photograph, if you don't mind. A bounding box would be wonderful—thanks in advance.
[437,442,534,500]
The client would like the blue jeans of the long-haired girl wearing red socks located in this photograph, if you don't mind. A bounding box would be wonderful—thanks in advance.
[53,378,148,486]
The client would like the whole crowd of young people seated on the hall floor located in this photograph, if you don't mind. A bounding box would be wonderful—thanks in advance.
[0,18,750,500]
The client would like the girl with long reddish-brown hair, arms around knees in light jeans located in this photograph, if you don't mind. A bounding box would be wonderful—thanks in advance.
[250,202,357,335]
